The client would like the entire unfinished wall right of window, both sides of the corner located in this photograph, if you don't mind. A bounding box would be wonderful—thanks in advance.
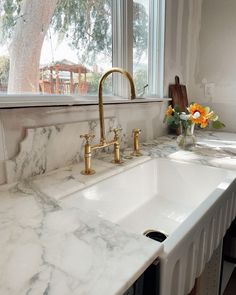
[165,0,236,132]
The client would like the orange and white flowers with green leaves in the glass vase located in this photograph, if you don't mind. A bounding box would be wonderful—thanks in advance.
[164,103,225,130]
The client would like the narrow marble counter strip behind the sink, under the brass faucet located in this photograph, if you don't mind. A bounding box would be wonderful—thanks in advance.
[30,153,151,201]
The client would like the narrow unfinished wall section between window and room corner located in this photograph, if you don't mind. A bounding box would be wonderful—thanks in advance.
[164,0,202,96]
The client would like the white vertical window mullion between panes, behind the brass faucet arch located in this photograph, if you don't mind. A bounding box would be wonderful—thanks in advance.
[112,0,133,97]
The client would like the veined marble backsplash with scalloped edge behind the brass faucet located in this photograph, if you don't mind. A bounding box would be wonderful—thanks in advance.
[5,117,126,183]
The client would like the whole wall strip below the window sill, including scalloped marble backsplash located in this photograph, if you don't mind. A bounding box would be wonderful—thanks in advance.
[0,101,167,184]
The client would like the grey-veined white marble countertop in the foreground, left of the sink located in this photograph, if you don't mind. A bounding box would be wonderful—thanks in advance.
[0,183,160,295]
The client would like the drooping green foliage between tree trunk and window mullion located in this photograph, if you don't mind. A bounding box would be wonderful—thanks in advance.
[52,0,112,65]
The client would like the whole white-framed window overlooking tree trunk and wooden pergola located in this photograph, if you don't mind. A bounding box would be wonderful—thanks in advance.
[0,0,164,97]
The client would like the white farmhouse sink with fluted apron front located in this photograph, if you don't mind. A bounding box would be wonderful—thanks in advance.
[61,158,236,295]
